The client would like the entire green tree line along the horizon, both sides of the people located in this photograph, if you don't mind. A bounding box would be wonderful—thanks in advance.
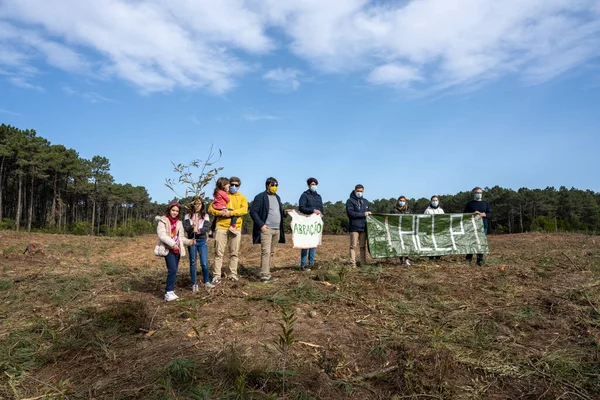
[0,124,600,236]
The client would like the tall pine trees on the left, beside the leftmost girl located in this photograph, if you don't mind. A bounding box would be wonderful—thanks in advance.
[0,124,164,235]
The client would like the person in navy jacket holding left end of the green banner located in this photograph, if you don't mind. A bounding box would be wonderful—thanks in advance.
[346,184,371,267]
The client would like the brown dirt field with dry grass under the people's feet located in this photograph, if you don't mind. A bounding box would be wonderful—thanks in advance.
[0,232,600,399]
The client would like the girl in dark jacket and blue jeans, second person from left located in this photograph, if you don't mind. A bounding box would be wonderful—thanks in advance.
[183,199,214,292]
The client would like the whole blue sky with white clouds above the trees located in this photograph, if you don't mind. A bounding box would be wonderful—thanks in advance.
[0,0,600,203]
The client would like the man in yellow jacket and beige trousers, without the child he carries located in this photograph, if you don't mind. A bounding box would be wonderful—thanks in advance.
[208,176,248,285]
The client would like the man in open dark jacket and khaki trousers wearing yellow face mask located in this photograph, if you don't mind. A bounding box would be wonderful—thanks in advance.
[250,177,288,282]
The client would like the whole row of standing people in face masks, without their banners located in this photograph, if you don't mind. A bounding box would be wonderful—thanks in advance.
[157,180,491,301]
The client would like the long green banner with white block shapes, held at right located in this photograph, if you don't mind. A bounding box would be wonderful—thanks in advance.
[367,214,489,258]
